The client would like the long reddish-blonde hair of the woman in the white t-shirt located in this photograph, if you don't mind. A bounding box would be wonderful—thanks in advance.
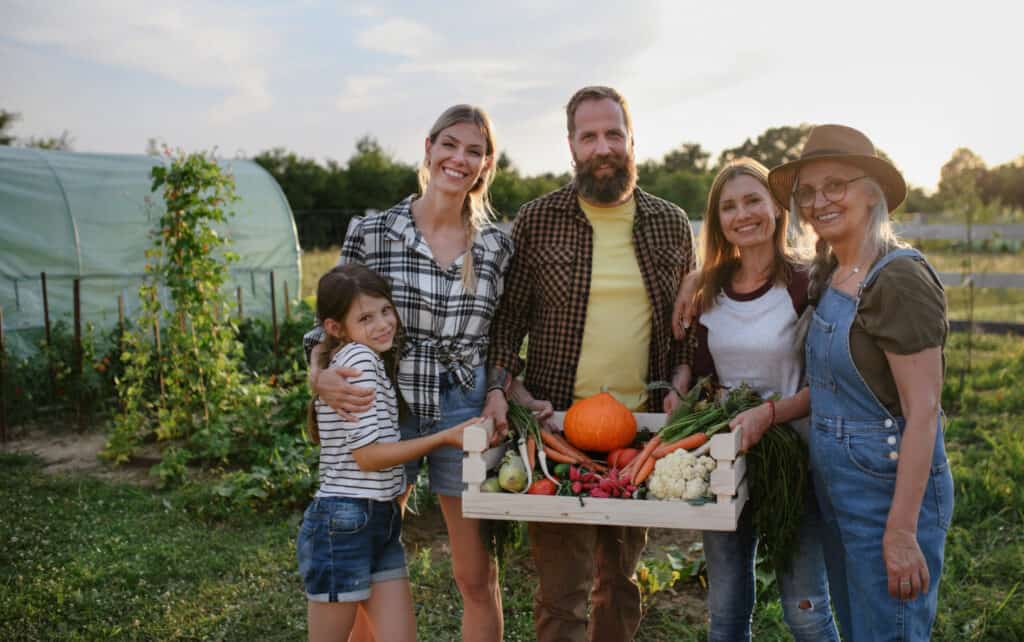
[696,157,800,310]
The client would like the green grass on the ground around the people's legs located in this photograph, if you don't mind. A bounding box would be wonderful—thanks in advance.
[0,335,1024,642]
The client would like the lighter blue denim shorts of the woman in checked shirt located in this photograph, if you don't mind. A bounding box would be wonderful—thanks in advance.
[399,366,487,497]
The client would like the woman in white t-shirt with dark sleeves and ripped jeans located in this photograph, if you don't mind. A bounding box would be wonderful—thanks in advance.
[666,158,839,642]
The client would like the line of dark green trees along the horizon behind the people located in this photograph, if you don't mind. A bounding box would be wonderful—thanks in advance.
[0,110,1024,246]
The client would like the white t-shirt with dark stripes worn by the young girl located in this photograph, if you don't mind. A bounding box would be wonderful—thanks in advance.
[315,343,406,500]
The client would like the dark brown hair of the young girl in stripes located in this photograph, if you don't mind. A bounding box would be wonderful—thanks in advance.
[306,263,402,443]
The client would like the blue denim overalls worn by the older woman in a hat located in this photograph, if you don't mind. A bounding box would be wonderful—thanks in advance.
[806,249,953,642]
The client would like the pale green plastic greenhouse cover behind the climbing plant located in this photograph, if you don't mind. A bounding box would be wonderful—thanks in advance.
[0,146,301,354]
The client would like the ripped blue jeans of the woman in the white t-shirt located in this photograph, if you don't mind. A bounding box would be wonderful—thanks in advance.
[703,487,839,642]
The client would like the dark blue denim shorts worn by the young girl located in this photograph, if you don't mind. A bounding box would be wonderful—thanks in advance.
[296,497,409,602]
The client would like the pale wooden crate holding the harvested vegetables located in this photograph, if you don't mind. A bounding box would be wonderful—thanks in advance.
[462,413,748,530]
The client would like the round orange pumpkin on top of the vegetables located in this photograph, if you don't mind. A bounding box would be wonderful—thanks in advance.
[562,392,637,453]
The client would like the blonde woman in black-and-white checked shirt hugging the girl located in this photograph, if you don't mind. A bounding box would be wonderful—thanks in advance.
[306,104,512,642]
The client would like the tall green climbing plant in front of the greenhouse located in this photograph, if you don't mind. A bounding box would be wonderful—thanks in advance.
[104,148,243,464]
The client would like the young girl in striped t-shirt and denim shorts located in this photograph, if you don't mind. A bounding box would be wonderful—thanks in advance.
[297,264,477,641]
